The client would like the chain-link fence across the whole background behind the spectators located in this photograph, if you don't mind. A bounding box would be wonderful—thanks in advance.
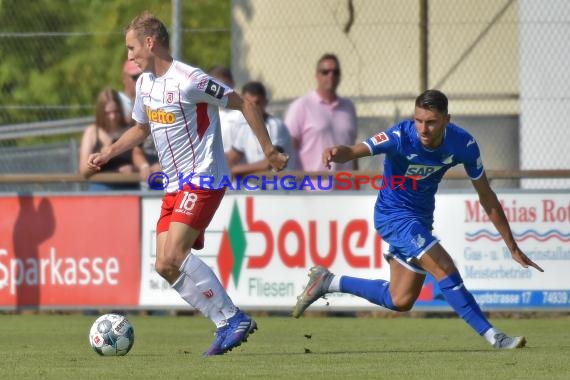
[0,0,570,188]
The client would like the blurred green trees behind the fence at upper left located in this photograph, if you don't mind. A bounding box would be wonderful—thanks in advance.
[0,0,231,125]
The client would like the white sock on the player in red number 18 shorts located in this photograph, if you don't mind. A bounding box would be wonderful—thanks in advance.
[180,253,238,319]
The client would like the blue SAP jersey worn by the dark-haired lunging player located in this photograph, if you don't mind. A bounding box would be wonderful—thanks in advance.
[364,120,484,228]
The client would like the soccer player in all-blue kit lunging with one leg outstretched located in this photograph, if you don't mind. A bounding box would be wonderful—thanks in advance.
[293,90,543,349]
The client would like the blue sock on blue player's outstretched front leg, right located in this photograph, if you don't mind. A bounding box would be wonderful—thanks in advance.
[439,273,492,335]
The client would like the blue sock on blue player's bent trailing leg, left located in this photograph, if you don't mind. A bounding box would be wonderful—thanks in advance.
[340,276,397,311]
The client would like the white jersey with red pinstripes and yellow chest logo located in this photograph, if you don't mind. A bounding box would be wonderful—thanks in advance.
[133,60,233,193]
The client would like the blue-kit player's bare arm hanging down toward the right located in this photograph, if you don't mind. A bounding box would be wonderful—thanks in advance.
[472,173,544,272]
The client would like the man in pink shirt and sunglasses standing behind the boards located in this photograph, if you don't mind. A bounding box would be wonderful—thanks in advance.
[285,54,357,171]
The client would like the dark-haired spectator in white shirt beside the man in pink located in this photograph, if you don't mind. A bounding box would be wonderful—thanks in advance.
[226,82,296,176]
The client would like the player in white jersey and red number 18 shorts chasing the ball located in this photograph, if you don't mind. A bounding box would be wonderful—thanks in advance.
[89,12,288,356]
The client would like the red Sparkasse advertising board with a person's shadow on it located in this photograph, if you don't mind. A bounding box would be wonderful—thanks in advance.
[0,195,140,309]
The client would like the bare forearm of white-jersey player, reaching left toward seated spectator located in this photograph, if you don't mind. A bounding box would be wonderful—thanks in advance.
[87,123,150,174]
